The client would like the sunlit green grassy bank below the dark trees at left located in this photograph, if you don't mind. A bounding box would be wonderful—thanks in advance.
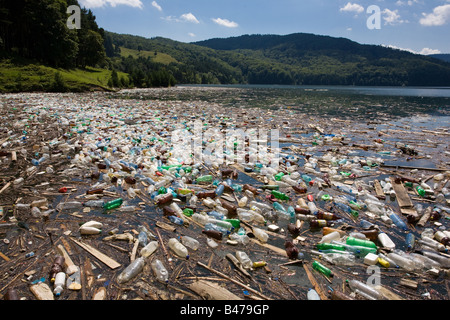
[0,59,127,93]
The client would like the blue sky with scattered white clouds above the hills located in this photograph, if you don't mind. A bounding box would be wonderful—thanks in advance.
[78,0,450,54]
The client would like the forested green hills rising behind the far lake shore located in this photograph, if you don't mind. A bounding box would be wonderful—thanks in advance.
[107,32,450,86]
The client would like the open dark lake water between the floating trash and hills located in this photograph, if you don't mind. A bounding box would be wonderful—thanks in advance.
[120,85,450,124]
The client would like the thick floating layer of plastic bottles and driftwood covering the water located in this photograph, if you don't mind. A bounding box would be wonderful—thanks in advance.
[0,89,450,300]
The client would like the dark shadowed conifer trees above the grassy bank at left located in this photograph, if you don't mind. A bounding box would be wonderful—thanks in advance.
[0,0,105,68]
